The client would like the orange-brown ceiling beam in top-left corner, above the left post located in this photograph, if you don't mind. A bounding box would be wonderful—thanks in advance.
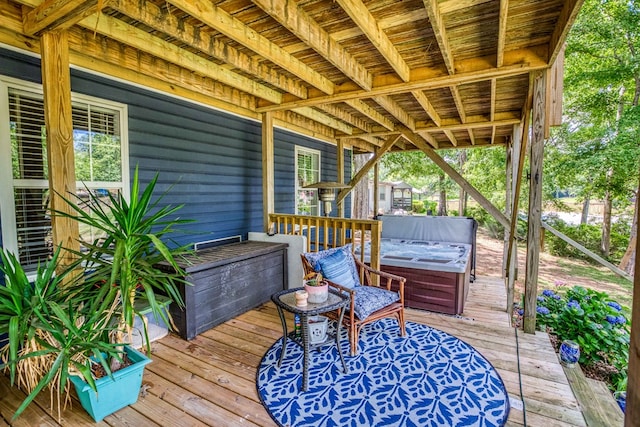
[23,0,109,36]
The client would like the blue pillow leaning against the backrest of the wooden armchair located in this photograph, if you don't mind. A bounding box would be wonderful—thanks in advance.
[304,244,360,288]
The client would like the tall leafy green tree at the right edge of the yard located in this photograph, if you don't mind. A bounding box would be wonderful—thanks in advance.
[545,0,640,260]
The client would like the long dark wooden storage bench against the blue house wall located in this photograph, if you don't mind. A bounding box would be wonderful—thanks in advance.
[165,241,287,340]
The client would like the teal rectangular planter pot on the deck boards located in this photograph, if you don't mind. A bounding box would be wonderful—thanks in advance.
[70,346,151,422]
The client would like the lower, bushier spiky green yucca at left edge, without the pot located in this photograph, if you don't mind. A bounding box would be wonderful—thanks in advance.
[0,248,121,419]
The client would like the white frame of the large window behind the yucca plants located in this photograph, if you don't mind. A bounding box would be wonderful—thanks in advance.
[0,75,130,274]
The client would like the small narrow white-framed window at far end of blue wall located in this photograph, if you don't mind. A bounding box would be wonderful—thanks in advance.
[295,147,320,215]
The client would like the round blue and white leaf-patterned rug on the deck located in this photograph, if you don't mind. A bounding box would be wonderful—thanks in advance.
[257,319,509,427]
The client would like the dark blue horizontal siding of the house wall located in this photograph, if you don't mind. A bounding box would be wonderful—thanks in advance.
[0,49,351,251]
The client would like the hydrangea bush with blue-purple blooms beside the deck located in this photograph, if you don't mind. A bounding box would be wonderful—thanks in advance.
[536,286,630,390]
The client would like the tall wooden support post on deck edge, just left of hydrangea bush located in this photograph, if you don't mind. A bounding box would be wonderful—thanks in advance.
[524,71,547,334]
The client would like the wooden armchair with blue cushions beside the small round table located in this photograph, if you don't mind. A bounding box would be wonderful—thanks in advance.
[300,245,406,356]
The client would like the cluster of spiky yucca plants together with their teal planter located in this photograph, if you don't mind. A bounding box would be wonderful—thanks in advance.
[0,168,191,421]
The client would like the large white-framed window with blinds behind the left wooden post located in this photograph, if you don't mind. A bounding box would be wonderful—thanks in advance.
[0,78,128,271]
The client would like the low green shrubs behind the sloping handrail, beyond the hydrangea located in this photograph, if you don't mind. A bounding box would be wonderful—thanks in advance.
[545,218,630,264]
